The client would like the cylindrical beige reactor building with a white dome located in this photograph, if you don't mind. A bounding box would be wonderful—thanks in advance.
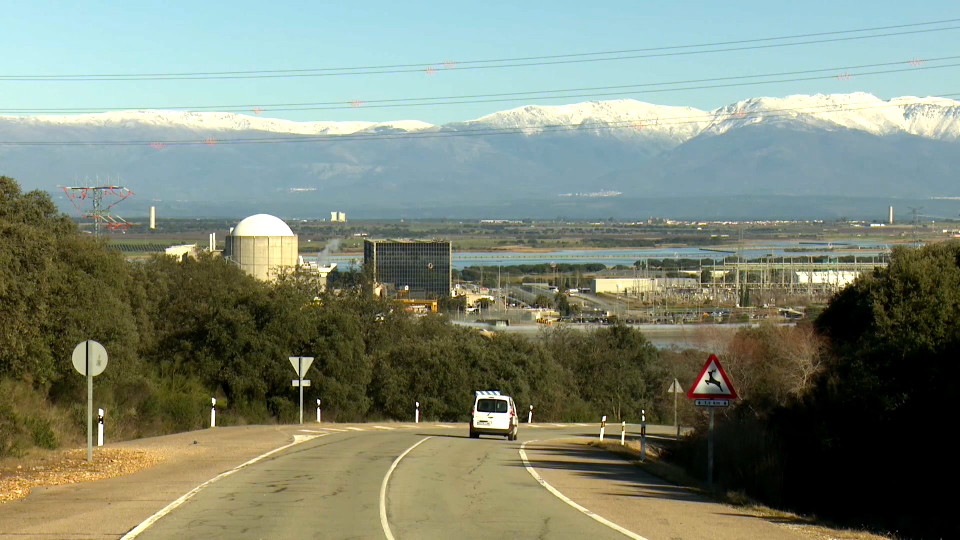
[223,214,299,281]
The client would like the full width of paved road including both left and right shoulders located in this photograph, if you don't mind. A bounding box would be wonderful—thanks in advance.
[0,423,810,540]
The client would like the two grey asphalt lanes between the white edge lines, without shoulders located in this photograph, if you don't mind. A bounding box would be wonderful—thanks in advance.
[131,426,623,540]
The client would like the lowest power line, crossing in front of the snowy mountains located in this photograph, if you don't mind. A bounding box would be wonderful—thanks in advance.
[0,92,960,146]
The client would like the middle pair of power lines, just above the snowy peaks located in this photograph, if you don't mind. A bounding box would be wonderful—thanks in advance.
[0,55,960,114]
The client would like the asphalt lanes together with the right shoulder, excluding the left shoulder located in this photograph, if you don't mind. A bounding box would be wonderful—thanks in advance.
[124,425,802,540]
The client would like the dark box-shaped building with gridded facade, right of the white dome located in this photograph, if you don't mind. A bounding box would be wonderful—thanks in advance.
[363,239,453,299]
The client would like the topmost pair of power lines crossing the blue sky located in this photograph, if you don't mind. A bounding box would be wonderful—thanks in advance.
[0,19,960,82]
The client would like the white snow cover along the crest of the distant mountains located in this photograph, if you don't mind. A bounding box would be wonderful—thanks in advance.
[7,92,960,141]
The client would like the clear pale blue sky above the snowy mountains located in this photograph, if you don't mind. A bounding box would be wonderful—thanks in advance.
[0,0,960,123]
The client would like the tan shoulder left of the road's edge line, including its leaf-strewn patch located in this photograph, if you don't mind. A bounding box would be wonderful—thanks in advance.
[0,426,299,539]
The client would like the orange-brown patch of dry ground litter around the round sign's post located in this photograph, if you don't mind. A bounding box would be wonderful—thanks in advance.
[0,448,163,504]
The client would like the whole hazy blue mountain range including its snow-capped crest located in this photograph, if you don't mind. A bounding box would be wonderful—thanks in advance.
[0,93,960,217]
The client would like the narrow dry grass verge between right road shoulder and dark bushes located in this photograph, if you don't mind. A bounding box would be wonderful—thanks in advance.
[586,440,894,540]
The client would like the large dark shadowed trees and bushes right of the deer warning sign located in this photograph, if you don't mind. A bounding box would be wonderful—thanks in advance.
[673,242,960,538]
